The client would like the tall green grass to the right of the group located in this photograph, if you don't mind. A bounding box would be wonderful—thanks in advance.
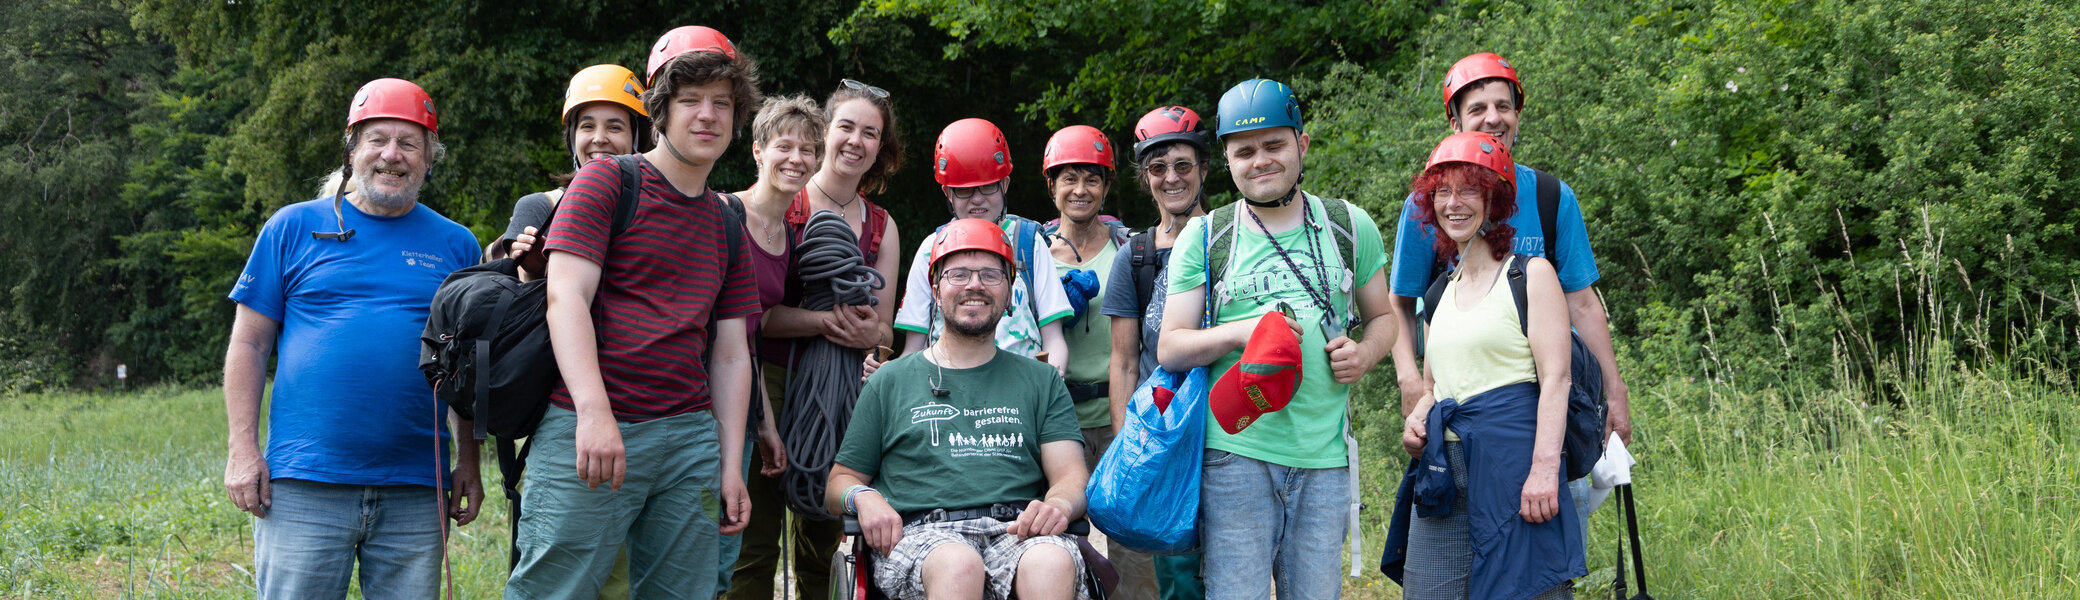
[1346,227,2080,598]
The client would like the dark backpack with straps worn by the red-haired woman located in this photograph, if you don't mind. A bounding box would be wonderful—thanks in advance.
[1423,254,1610,481]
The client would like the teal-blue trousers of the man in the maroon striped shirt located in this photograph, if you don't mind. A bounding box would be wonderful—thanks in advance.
[505,406,722,600]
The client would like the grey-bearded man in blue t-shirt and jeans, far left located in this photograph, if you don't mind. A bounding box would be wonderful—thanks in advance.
[225,79,485,598]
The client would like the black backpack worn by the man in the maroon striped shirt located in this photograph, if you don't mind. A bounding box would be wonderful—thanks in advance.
[418,154,745,563]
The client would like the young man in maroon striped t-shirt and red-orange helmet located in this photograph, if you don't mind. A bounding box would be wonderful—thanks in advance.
[505,27,761,598]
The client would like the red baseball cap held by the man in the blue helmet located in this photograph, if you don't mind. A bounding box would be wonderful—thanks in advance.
[1206,310,1300,433]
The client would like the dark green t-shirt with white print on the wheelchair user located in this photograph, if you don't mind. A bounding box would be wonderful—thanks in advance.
[836,350,1084,513]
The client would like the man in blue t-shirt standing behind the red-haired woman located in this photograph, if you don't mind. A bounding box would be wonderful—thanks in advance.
[1394,52,1633,515]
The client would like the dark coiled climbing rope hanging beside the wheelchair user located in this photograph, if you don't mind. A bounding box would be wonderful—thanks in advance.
[778,210,886,521]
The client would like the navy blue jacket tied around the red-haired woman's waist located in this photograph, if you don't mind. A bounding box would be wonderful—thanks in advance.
[1379,383,1589,598]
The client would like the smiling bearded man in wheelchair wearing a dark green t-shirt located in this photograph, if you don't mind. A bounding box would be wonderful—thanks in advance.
[826,219,1094,600]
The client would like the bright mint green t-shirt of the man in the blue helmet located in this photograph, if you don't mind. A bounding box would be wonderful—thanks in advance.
[1169,194,1385,469]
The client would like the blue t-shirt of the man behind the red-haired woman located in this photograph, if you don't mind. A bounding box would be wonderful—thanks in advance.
[1392,165,1602,298]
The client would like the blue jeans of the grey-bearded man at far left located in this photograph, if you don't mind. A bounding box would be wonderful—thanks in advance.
[254,479,443,600]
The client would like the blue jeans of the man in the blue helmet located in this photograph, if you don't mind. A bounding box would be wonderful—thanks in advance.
[1198,448,1350,600]
